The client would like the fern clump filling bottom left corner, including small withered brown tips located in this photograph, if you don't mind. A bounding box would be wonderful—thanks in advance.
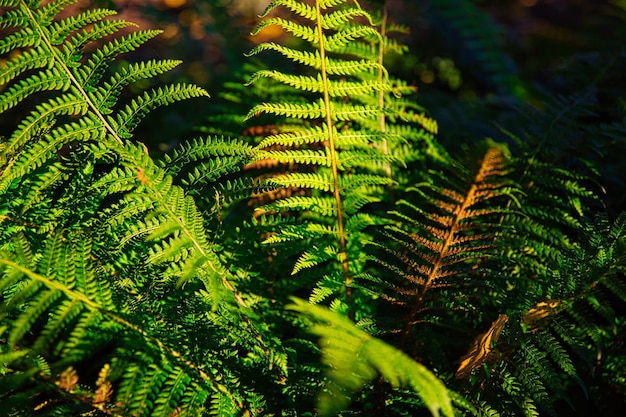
[0,233,254,416]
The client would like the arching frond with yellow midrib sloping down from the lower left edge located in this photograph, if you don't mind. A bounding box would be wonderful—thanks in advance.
[0,235,254,416]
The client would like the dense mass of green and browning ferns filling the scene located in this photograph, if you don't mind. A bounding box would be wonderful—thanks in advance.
[0,0,626,417]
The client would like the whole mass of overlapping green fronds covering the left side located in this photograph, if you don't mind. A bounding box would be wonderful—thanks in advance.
[0,1,286,416]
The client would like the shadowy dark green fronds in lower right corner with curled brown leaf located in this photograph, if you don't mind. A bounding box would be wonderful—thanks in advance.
[457,211,626,415]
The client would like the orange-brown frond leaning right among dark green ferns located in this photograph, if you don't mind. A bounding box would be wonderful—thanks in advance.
[360,148,515,326]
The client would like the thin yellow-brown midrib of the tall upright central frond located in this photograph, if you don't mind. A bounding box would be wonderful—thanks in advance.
[315,0,354,310]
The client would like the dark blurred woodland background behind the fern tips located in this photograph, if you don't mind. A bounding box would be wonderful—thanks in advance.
[90,0,626,214]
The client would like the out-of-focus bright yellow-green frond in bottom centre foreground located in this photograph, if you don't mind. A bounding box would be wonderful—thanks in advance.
[288,299,454,416]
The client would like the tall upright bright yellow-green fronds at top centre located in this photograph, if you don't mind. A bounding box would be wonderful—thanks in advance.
[248,0,432,312]
